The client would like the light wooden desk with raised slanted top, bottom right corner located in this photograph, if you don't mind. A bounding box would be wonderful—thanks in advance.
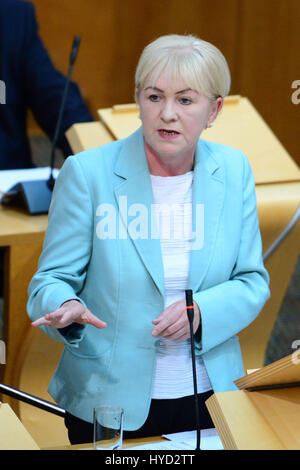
[205,353,300,450]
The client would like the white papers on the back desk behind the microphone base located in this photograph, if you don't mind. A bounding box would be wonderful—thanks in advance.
[0,166,59,201]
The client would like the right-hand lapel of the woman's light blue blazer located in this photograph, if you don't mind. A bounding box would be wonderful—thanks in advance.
[188,140,225,292]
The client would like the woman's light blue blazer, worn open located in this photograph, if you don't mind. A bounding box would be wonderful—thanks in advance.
[28,128,269,430]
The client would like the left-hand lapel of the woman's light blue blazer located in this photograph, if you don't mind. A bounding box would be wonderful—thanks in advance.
[114,128,164,295]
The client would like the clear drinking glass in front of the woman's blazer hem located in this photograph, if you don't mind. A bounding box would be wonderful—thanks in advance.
[94,406,124,450]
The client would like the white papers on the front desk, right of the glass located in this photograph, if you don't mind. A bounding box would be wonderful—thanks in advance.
[124,428,224,450]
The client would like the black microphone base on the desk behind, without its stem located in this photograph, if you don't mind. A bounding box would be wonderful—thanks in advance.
[1,180,52,215]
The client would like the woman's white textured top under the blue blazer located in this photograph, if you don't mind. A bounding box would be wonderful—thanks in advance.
[151,171,212,399]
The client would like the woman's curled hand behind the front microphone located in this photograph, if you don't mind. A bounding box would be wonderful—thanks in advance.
[152,300,200,341]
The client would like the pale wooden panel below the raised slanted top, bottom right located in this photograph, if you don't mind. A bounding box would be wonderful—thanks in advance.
[205,387,300,450]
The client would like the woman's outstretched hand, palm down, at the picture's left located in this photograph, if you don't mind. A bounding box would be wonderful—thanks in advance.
[32,299,106,328]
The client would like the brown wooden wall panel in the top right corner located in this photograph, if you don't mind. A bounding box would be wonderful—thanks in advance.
[236,0,300,165]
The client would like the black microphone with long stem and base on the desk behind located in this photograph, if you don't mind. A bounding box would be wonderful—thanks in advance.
[1,36,80,215]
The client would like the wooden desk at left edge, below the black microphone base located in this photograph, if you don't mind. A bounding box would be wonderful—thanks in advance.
[0,205,48,414]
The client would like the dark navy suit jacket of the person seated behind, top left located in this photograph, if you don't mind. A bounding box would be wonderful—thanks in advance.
[0,0,93,170]
